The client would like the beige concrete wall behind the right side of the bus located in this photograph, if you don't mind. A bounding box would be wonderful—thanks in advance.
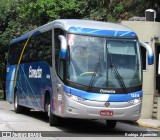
[121,21,160,119]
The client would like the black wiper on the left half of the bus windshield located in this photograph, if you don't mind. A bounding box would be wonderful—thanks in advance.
[87,62,100,92]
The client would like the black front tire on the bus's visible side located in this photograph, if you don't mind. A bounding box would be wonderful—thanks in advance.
[48,104,60,126]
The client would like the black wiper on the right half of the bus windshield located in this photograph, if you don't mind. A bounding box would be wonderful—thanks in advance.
[110,57,127,93]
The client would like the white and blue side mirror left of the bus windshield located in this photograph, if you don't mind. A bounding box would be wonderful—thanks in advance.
[58,35,67,59]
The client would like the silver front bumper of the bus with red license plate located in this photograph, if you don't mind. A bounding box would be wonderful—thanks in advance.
[62,95,141,121]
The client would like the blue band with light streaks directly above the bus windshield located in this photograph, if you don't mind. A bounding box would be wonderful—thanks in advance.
[68,27,137,38]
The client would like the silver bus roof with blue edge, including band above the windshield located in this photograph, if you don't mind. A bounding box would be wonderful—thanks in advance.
[11,19,137,44]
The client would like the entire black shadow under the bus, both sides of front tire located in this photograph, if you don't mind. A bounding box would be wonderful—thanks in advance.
[12,111,124,136]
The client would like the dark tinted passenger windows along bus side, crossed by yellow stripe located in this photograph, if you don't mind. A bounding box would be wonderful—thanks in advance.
[8,31,52,65]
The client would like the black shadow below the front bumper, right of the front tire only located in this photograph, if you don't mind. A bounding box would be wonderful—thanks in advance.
[58,119,120,135]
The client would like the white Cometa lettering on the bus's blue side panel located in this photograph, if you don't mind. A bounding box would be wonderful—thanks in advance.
[29,66,42,78]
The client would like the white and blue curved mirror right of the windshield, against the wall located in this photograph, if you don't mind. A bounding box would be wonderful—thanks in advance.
[140,42,154,65]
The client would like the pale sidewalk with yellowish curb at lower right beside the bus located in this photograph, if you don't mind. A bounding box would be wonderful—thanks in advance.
[137,119,160,130]
